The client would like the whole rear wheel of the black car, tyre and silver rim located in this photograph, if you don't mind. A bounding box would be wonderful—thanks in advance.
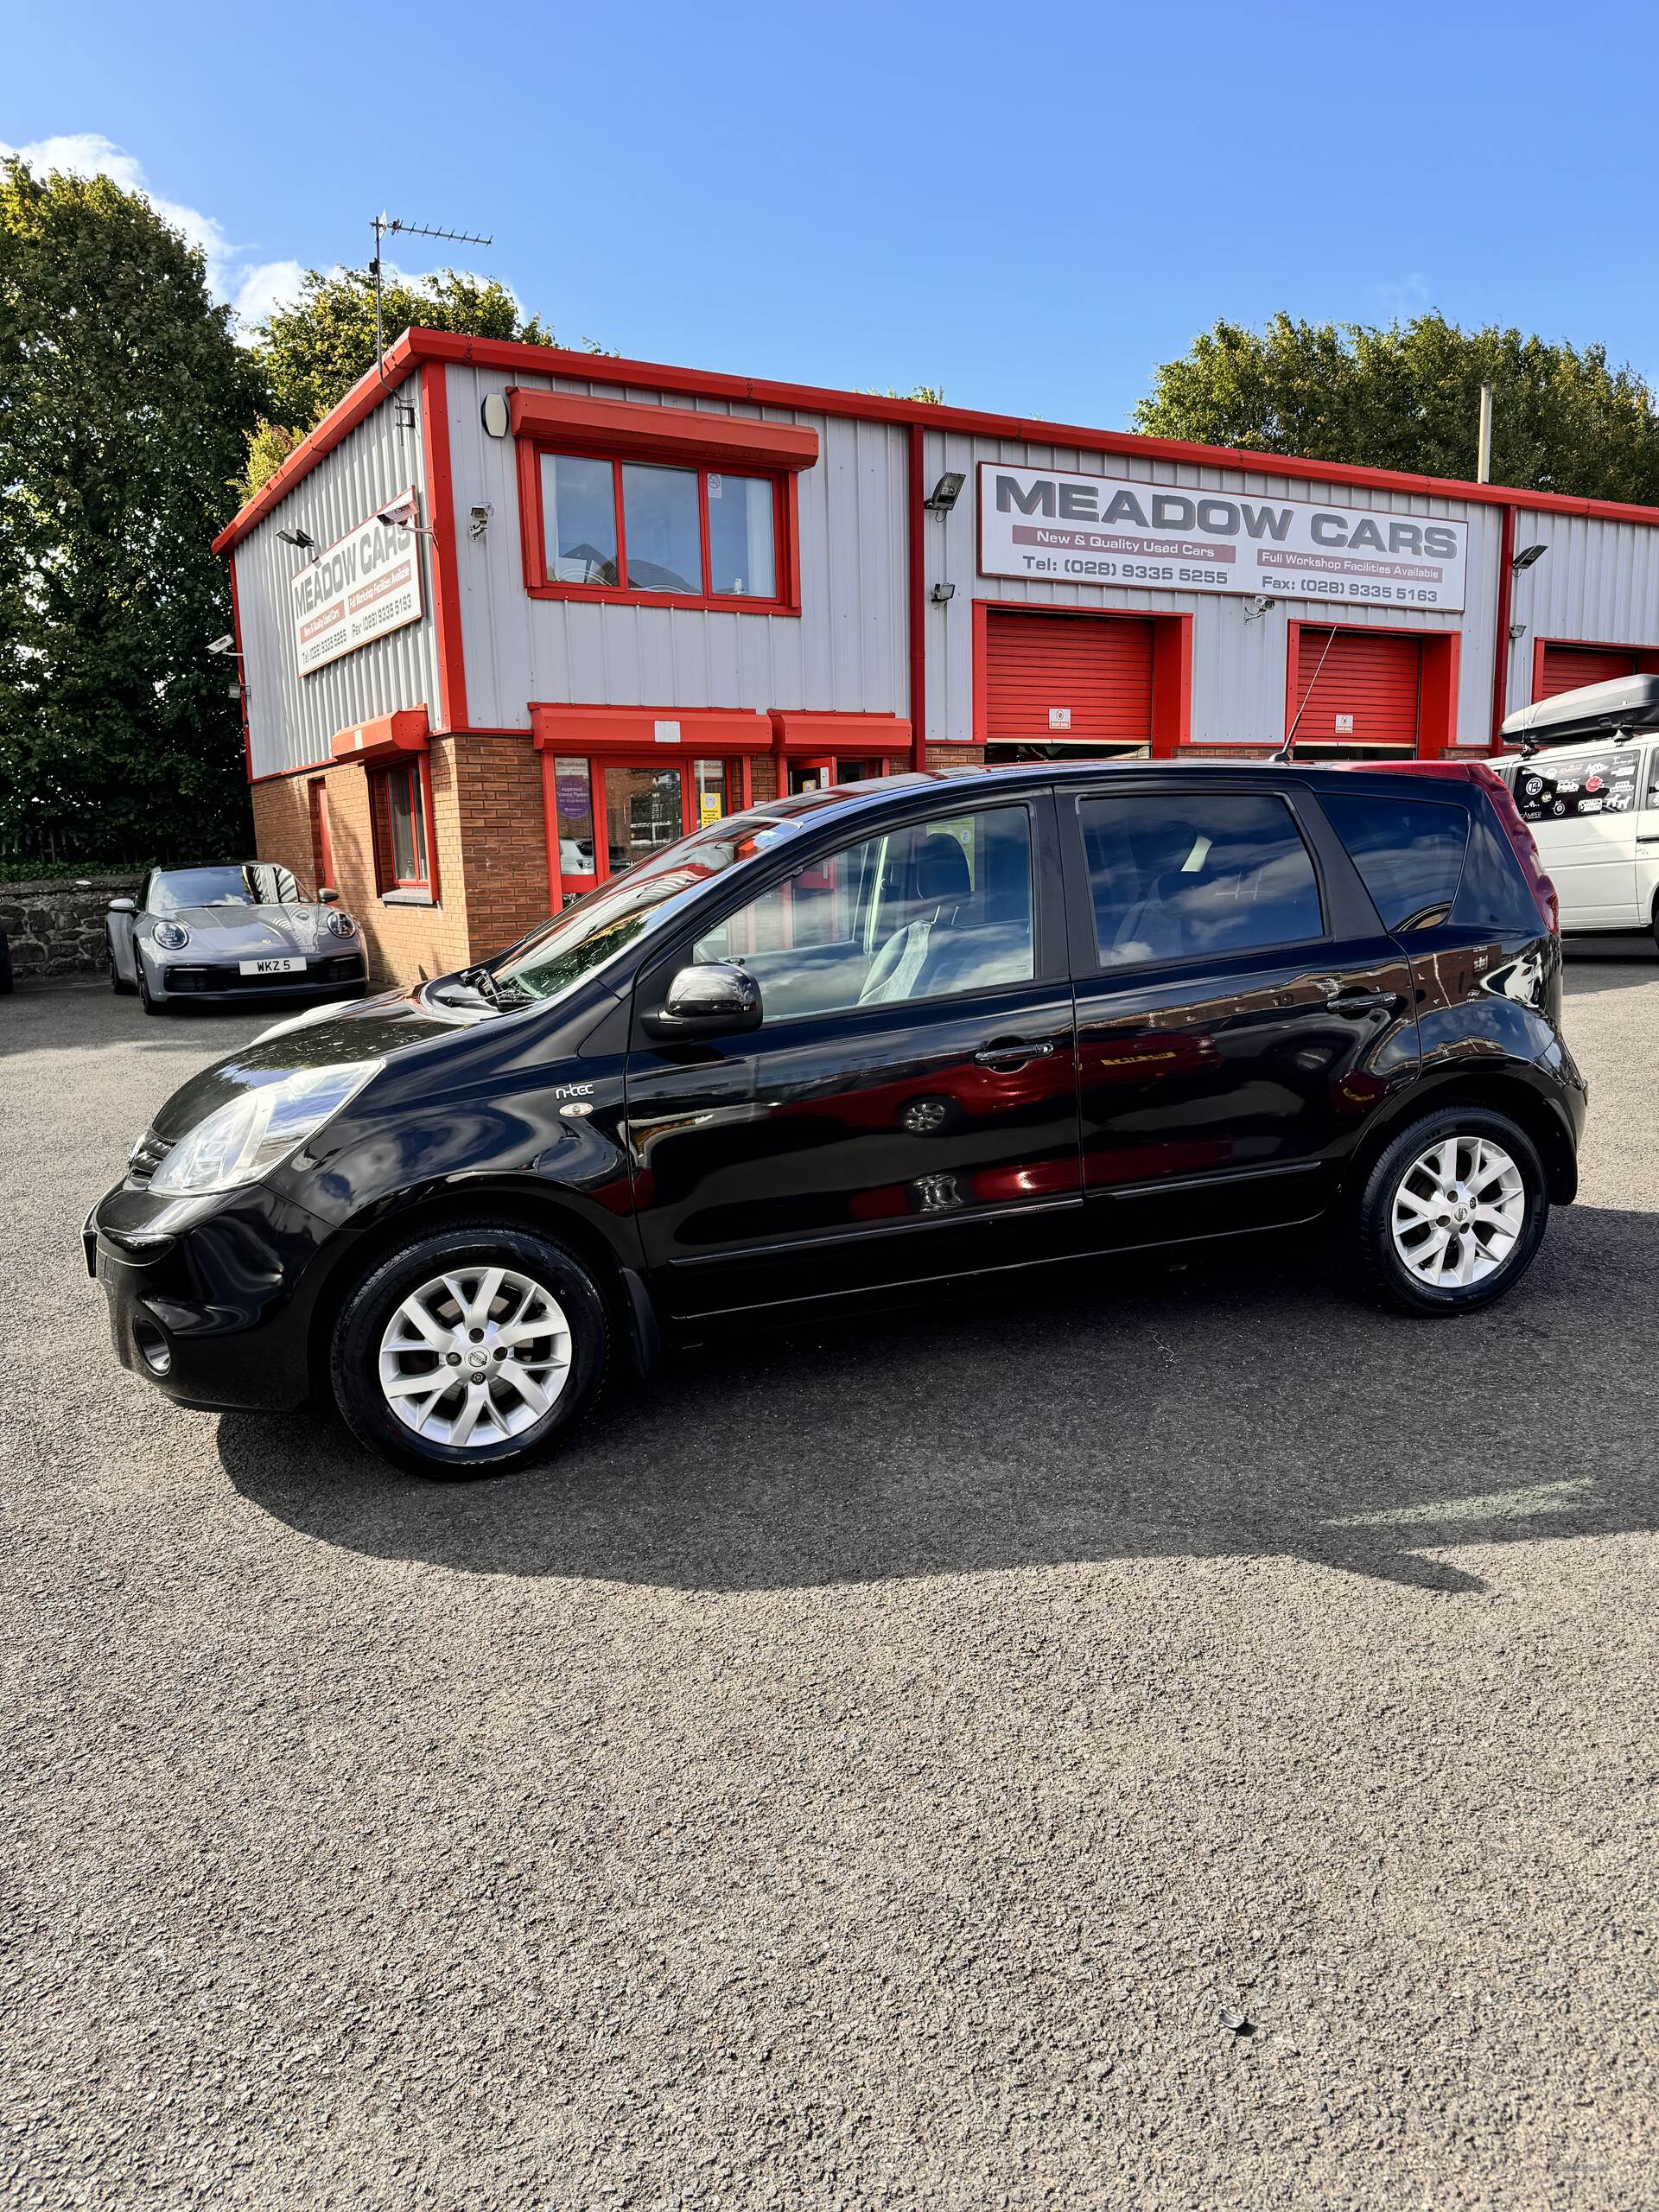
[1356,1106,1551,1316]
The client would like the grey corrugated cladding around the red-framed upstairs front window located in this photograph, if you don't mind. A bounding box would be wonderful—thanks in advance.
[447,365,909,730]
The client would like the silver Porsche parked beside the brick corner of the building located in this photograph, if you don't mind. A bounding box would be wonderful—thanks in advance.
[106,861,370,1013]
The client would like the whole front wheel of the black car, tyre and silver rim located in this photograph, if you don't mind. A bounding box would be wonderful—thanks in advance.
[329,1221,608,1478]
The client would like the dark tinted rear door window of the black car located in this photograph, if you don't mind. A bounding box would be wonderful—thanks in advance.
[1077,791,1325,967]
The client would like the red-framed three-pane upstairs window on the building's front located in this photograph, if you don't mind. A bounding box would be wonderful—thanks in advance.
[537,454,787,611]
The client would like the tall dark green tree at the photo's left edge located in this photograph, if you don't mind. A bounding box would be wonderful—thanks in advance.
[0,159,259,862]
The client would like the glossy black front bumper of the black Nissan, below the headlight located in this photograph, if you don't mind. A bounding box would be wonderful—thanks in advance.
[82,1184,323,1411]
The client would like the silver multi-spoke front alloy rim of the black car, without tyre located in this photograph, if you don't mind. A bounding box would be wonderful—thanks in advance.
[380,1268,570,1451]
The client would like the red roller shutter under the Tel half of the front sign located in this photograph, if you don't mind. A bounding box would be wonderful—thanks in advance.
[984,608,1153,746]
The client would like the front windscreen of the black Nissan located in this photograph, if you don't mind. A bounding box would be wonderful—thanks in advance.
[489,814,803,1000]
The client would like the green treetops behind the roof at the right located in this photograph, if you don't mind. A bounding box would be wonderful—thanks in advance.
[1135,315,1659,505]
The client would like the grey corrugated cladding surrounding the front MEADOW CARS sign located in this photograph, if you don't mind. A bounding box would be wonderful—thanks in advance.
[923,431,1503,741]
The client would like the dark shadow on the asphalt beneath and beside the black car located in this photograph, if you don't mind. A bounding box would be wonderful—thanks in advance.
[219,1208,1659,1592]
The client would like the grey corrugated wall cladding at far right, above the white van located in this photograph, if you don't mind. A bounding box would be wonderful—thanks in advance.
[1503,509,1659,710]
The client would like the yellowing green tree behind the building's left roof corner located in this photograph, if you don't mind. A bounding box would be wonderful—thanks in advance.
[238,270,583,500]
